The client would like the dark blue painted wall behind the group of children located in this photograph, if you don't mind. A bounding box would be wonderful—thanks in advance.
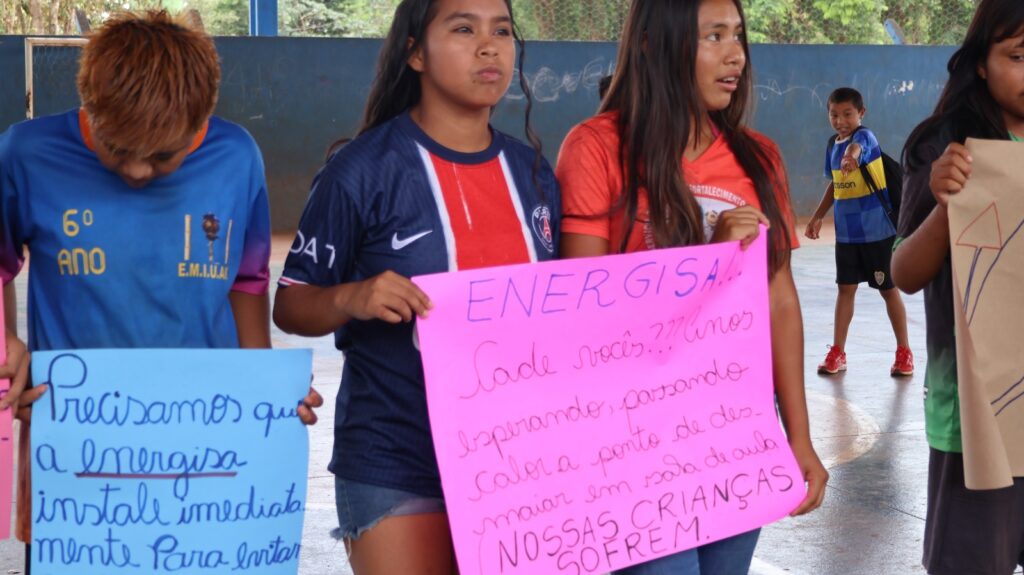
[0,36,953,230]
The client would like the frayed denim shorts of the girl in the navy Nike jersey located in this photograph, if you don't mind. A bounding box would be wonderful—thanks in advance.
[331,476,445,539]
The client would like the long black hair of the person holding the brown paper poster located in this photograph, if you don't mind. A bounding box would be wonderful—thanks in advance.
[903,0,1024,170]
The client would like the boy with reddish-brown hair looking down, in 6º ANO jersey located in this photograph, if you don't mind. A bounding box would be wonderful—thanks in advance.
[0,11,322,559]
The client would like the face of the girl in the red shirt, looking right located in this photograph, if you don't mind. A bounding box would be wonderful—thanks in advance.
[696,0,746,112]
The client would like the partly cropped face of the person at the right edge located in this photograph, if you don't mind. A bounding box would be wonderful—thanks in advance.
[978,34,1024,136]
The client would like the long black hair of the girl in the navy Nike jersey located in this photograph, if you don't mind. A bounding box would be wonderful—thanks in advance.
[329,0,543,165]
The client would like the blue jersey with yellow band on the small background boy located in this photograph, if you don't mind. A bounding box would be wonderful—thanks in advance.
[825,128,896,244]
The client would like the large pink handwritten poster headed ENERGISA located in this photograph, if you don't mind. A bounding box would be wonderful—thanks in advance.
[414,234,806,575]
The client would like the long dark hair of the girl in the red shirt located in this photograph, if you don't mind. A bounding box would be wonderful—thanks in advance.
[601,0,792,271]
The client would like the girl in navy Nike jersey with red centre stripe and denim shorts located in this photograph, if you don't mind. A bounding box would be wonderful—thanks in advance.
[273,0,560,575]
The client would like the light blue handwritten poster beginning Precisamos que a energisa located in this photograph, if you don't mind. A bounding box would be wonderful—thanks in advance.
[32,350,312,575]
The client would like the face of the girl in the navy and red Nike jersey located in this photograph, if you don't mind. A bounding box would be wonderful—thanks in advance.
[409,0,515,110]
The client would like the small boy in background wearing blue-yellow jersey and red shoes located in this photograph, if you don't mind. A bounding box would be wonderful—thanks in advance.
[804,88,913,375]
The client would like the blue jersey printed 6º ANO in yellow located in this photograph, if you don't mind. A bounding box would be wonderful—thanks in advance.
[0,110,270,350]
